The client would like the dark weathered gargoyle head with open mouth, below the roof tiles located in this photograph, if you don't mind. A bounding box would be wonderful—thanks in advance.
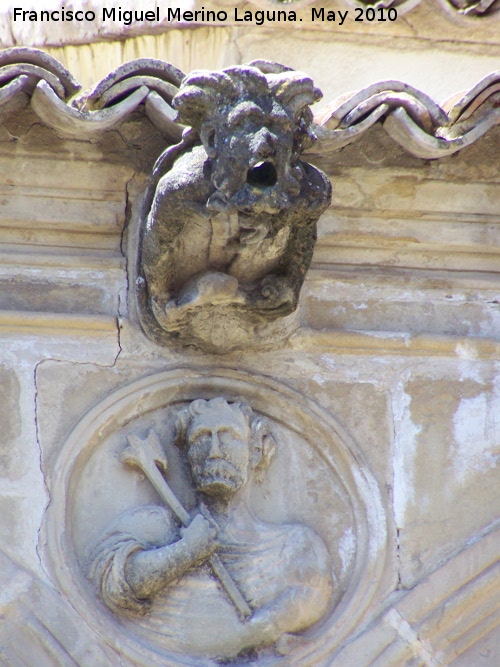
[173,62,321,213]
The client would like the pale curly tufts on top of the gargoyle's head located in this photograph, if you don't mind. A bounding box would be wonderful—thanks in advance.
[172,61,322,142]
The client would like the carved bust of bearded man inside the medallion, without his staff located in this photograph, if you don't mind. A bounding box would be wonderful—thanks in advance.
[89,398,333,664]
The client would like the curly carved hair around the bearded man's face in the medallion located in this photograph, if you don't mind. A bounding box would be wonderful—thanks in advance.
[175,396,276,472]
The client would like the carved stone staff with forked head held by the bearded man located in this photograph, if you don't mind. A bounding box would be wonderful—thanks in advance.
[120,429,252,619]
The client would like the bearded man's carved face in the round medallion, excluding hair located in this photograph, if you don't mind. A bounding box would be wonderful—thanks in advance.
[187,406,250,498]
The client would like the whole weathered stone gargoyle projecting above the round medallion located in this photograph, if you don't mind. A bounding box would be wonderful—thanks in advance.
[136,61,331,353]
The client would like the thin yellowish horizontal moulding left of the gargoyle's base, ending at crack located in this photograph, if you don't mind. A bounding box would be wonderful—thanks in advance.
[0,310,116,337]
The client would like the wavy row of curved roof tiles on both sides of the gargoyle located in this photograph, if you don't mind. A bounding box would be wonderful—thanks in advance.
[0,47,500,159]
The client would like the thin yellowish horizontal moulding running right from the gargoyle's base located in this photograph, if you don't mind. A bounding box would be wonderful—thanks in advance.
[290,328,500,360]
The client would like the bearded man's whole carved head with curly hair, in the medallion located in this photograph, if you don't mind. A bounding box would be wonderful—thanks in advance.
[177,397,274,498]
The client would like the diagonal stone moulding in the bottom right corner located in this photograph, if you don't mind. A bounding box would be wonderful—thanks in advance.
[332,526,500,667]
